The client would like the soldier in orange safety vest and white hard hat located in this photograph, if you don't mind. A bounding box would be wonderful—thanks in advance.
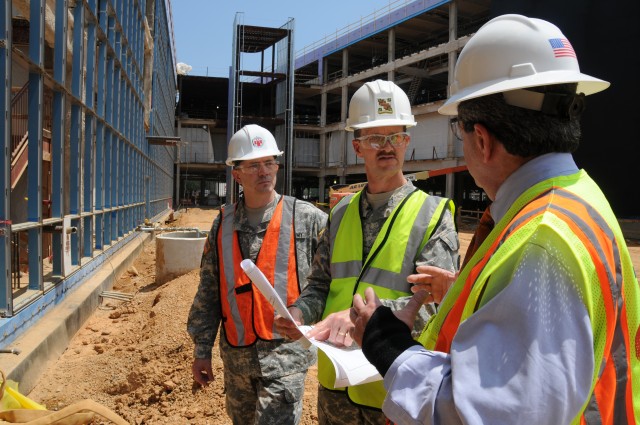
[187,124,327,425]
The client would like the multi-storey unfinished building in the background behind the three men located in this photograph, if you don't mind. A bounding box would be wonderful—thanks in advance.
[175,0,640,219]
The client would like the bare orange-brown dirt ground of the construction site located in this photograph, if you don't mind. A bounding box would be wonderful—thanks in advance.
[28,208,640,425]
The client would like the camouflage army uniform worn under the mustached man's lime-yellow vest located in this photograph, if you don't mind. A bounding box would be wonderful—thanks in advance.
[294,181,459,425]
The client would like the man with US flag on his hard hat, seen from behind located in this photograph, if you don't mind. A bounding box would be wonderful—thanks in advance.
[351,15,640,425]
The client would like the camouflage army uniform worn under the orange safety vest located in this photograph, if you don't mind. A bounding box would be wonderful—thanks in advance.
[187,195,327,424]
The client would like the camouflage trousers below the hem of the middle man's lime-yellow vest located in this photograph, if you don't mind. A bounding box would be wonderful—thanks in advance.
[318,385,388,425]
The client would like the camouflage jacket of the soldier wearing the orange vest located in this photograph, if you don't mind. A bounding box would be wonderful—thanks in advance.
[187,195,327,377]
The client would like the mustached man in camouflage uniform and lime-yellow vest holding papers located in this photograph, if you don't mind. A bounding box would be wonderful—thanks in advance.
[276,80,459,425]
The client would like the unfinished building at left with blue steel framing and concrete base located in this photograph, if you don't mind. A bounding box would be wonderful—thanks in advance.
[0,0,177,390]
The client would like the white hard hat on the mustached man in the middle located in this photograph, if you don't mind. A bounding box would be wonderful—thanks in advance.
[345,80,416,131]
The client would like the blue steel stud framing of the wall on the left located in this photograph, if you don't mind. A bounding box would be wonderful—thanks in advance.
[0,0,176,345]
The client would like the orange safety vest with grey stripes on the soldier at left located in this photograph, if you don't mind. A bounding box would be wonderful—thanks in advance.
[216,196,300,347]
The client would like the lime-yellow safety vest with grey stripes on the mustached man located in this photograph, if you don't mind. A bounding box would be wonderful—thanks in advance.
[318,190,453,408]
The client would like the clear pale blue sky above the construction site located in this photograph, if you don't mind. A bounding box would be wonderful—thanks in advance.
[171,0,398,77]
